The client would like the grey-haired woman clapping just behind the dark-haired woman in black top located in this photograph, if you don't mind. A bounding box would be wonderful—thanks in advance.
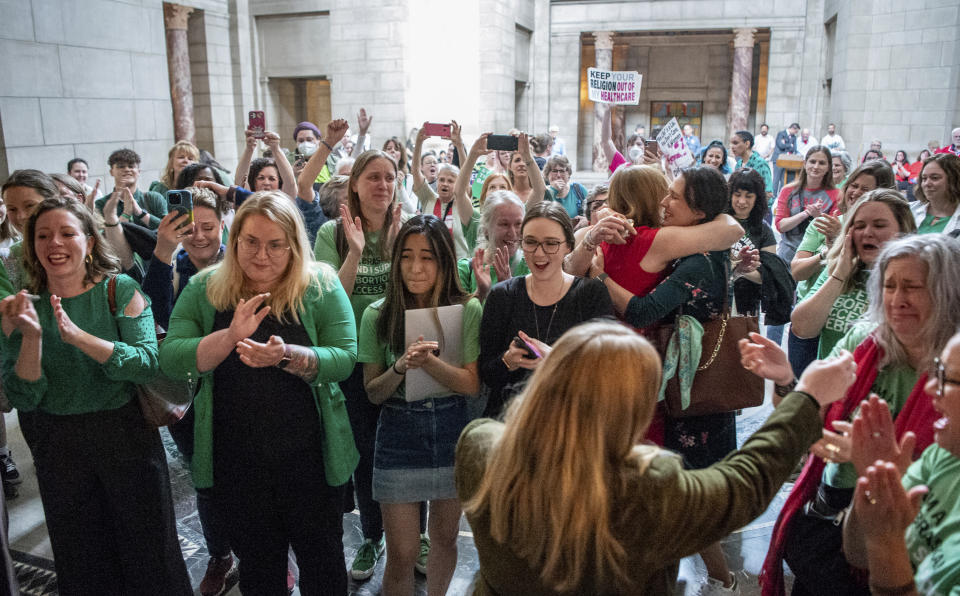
[457,190,530,301]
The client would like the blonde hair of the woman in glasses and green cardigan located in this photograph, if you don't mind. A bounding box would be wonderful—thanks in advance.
[207,190,336,323]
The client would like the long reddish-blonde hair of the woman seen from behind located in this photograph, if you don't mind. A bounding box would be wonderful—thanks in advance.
[464,322,660,592]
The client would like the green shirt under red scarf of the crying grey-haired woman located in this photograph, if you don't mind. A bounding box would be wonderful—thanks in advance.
[823,323,920,488]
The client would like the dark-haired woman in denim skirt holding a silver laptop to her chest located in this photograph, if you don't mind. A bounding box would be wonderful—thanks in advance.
[359,215,482,596]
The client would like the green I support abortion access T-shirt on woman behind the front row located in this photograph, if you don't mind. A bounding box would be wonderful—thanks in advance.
[313,219,390,326]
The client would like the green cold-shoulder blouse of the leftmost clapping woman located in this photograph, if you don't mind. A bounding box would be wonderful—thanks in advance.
[0,275,159,415]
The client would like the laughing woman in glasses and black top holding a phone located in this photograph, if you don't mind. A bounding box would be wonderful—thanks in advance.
[480,202,613,417]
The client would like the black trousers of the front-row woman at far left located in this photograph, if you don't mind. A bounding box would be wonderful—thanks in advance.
[20,400,193,596]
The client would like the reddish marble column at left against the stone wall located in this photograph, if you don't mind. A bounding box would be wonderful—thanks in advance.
[163,2,197,143]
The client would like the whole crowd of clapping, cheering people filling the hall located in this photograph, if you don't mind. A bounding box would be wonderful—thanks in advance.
[0,110,960,596]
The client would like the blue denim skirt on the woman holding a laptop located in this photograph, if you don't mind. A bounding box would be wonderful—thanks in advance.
[373,395,469,503]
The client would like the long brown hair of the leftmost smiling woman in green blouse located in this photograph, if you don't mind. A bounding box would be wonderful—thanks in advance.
[23,197,120,294]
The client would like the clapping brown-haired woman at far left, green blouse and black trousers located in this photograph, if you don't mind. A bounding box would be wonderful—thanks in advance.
[0,198,192,595]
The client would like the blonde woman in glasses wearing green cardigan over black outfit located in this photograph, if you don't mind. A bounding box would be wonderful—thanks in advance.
[160,191,358,594]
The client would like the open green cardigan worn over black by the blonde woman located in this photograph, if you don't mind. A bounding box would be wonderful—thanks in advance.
[160,266,360,488]
